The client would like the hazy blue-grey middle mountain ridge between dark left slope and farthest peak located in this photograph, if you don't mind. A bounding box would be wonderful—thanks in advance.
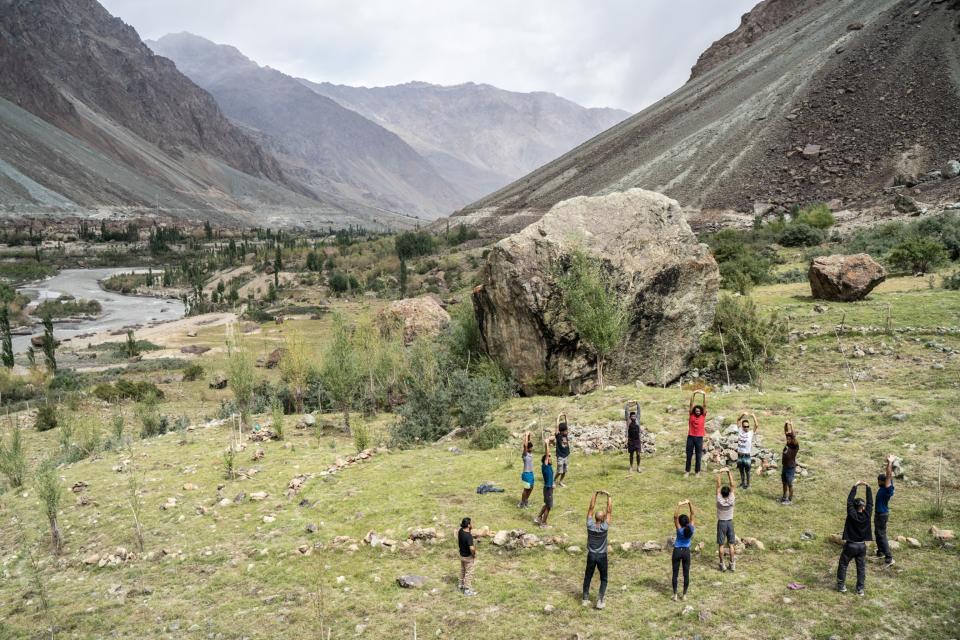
[148,33,468,219]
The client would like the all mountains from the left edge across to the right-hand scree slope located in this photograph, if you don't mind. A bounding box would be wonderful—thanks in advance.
[0,0,626,227]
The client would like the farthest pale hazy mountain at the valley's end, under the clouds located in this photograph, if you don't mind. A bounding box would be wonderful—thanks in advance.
[302,80,630,198]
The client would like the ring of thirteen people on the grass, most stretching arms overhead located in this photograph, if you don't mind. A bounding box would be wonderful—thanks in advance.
[457,391,894,609]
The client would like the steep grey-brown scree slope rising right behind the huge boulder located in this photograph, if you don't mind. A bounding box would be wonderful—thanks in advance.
[455,0,960,235]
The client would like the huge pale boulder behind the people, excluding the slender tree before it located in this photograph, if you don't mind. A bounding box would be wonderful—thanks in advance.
[473,189,720,393]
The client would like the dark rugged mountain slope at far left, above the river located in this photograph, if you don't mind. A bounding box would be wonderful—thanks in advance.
[0,0,394,224]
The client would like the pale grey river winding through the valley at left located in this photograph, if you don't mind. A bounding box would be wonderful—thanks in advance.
[13,267,185,353]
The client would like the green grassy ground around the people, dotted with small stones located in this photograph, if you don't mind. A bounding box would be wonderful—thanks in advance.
[0,278,960,638]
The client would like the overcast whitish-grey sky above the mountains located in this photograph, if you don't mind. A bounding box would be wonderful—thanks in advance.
[101,0,757,111]
